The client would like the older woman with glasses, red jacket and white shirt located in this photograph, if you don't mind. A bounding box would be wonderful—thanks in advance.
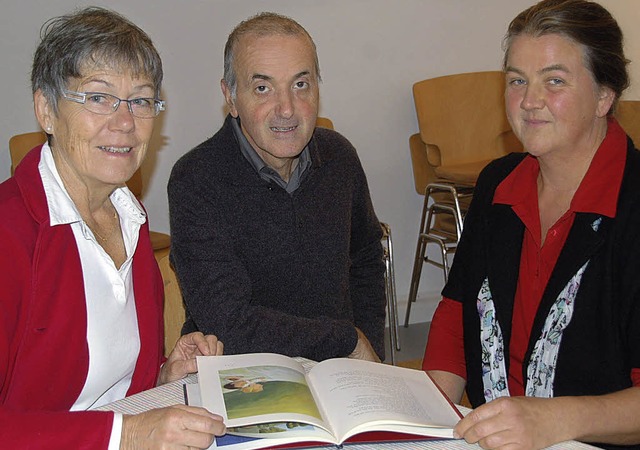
[0,8,224,449]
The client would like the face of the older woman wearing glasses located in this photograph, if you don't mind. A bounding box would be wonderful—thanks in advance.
[36,69,155,190]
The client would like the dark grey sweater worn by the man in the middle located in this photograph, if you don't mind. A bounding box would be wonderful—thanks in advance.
[168,116,385,360]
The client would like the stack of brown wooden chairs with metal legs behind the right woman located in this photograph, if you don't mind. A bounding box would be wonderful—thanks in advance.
[404,71,522,327]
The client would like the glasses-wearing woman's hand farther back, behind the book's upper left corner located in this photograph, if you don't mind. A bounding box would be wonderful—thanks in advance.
[158,331,224,385]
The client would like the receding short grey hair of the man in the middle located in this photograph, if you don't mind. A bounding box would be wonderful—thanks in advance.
[224,12,321,98]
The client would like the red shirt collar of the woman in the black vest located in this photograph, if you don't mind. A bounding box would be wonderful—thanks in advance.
[493,119,627,217]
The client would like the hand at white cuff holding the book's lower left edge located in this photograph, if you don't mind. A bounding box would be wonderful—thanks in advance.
[120,405,226,450]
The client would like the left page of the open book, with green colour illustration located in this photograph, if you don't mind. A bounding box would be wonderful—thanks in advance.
[197,353,327,432]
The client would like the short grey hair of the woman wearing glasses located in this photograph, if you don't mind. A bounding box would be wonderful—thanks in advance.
[31,7,163,112]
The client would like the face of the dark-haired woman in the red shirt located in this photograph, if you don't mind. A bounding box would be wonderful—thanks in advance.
[505,34,614,160]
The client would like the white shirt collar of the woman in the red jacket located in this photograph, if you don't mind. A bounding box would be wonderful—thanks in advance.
[38,143,147,226]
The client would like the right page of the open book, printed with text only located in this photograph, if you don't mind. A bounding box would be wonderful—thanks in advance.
[308,358,461,442]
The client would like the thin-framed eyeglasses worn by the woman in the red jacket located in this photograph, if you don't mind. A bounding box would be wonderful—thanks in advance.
[62,90,165,119]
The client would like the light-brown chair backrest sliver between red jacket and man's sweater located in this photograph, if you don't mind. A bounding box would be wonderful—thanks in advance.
[158,255,185,356]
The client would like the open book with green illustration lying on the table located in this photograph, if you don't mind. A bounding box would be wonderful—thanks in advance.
[192,353,462,450]
